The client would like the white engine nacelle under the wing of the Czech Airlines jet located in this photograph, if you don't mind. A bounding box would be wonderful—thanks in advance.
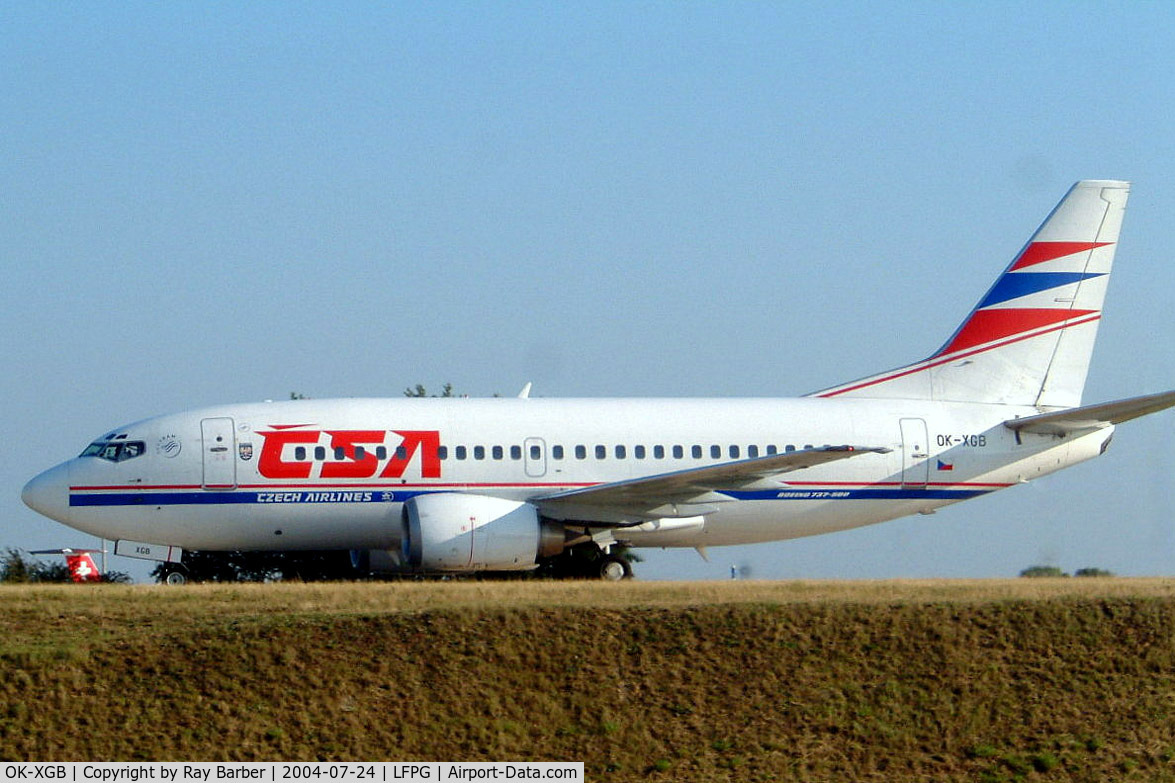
[401,493,564,571]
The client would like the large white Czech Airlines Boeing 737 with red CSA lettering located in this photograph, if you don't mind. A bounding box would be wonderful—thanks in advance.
[22,180,1175,582]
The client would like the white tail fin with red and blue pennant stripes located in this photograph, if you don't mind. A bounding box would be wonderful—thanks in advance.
[812,180,1130,408]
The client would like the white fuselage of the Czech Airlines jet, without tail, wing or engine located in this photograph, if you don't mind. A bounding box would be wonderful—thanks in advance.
[26,397,1113,550]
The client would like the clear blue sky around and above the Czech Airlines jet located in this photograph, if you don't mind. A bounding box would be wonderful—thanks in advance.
[0,2,1175,578]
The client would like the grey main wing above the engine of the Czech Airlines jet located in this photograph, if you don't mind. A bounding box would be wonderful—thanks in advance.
[530,446,889,516]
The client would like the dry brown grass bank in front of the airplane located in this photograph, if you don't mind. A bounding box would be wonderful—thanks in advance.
[0,578,1175,781]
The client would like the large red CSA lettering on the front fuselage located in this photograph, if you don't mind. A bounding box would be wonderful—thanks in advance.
[257,424,441,479]
